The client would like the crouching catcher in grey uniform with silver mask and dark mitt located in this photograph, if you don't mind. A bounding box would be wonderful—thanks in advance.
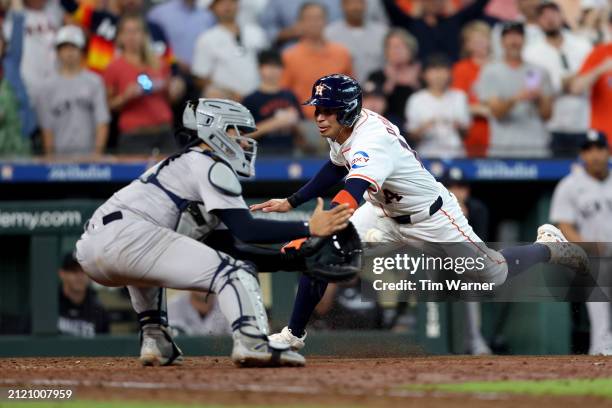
[76,99,360,366]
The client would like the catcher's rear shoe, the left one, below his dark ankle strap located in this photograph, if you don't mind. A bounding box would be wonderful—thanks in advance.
[139,324,183,366]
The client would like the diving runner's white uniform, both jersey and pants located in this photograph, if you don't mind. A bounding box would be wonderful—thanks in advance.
[328,109,508,285]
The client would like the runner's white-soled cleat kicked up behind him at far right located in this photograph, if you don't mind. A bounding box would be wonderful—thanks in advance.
[536,224,589,275]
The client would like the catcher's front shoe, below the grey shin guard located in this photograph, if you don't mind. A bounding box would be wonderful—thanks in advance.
[231,332,306,367]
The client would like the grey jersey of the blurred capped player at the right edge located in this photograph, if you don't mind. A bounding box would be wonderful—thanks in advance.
[550,168,612,242]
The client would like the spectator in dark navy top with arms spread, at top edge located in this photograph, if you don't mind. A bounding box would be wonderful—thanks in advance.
[383,0,489,61]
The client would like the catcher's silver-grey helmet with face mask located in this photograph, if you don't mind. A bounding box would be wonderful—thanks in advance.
[180,98,257,177]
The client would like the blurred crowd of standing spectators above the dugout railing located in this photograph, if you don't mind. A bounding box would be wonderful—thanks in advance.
[0,0,612,158]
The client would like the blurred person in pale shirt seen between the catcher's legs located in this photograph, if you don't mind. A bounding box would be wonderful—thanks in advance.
[168,291,232,336]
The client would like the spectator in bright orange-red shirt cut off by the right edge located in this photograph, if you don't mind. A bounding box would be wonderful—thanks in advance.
[571,17,612,148]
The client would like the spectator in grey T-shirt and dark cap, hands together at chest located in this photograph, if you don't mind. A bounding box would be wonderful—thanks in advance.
[476,23,552,157]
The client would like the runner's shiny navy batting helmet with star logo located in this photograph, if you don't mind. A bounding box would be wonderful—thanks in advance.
[304,74,361,127]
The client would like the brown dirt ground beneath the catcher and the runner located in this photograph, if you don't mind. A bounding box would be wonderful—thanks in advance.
[0,356,612,408]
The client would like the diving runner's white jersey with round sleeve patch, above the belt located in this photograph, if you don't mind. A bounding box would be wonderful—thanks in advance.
[327,109,444,217]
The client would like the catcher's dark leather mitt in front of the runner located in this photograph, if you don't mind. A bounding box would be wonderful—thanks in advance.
[284,223,363,282]
